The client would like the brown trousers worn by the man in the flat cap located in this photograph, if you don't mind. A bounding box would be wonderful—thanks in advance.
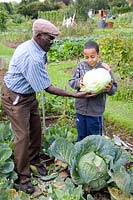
[1,84,41,176]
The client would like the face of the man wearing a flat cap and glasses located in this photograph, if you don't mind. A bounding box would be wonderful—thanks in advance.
[39,33,55,52]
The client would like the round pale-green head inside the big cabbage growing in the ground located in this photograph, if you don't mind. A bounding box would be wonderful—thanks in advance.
[77,152,109,190]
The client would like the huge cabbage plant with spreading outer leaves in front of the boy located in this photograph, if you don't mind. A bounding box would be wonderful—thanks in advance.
[50,135,133,194]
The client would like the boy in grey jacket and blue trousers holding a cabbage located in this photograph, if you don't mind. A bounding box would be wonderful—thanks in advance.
[69,40,117,141]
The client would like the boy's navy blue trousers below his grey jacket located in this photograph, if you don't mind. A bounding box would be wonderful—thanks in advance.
[76,113,103,141]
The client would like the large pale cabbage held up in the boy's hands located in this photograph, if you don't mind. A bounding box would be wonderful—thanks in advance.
[80,68,111,94]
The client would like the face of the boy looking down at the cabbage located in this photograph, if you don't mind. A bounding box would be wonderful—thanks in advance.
[83,48,99,67]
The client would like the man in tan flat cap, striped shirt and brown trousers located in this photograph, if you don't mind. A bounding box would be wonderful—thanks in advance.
[2,19,85,194]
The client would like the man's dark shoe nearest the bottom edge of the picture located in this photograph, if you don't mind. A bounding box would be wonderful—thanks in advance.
[19,178,35,194]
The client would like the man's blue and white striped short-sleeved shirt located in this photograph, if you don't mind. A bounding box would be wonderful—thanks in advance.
[4,38,51,94]
